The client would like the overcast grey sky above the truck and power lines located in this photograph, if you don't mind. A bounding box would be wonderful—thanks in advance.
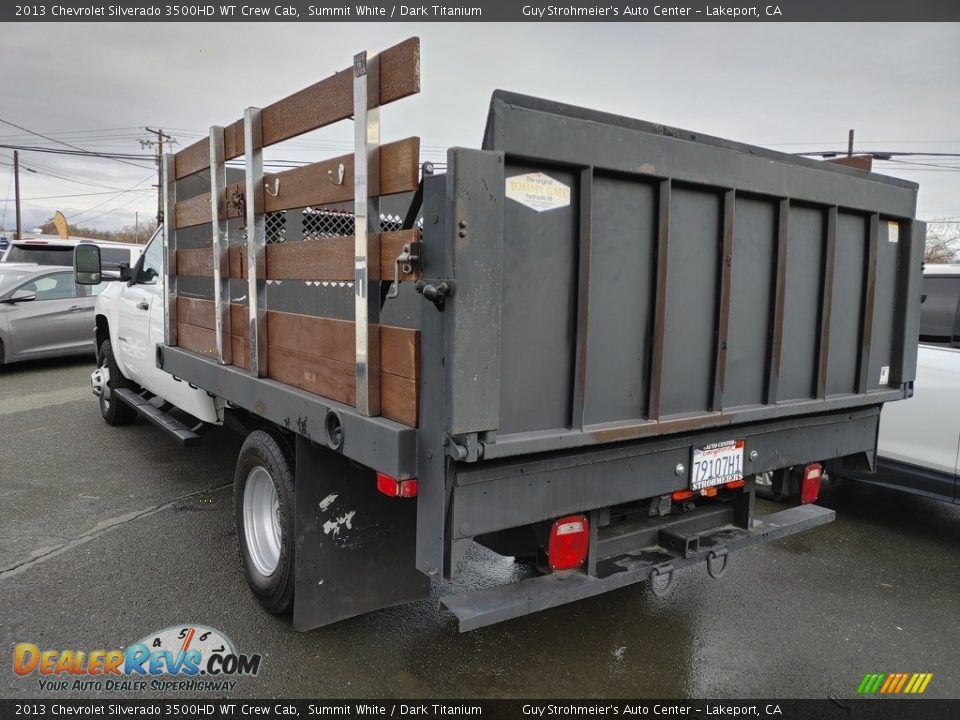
[0,22,960,234]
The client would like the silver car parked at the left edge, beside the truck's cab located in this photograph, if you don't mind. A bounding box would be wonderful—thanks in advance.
[0,263,105,364]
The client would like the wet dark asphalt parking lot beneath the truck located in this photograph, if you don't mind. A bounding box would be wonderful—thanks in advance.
[0,358,960,698]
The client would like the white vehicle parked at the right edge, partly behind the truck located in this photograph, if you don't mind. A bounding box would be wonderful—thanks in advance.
[757,265,960,503]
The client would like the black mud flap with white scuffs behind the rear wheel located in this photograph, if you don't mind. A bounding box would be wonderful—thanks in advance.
[293,436,430,631]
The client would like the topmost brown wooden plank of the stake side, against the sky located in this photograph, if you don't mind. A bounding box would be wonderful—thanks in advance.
[175,37,420,180]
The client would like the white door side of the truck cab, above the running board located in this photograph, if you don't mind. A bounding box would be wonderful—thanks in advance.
[115,235,163,392]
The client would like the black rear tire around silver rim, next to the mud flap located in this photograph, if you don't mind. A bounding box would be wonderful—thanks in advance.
[233,430,296,615]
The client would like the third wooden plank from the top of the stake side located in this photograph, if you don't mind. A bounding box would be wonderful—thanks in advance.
[177,230,418,282]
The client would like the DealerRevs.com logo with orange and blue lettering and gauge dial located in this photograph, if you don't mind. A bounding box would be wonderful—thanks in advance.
[13,624,261,692]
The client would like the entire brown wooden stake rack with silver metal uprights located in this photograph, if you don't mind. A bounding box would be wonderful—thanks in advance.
[163,38,420,426]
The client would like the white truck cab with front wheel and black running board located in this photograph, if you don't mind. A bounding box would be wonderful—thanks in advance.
[90,231,223,434]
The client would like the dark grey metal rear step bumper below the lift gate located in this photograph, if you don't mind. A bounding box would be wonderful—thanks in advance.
[440,505,836,632]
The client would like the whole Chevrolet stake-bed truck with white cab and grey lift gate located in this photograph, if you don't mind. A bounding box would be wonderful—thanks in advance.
[76,39,925,630]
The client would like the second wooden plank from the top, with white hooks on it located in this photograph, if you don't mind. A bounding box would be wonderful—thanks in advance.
[176,137,420,230]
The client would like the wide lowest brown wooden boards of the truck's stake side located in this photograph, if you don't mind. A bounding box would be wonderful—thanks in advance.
[177,297,420,427]
